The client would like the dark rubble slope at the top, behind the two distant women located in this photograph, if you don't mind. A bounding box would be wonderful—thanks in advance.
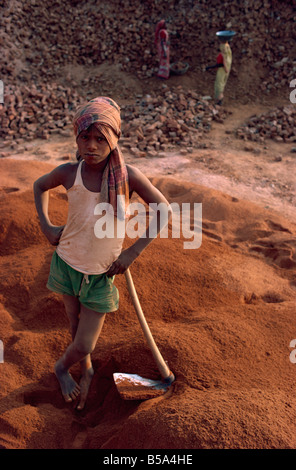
[0,0,296,87]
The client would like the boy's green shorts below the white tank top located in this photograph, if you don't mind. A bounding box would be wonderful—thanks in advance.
[47,252,119,313]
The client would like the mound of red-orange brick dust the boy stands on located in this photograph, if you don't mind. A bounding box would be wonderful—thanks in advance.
[0,161,296,449]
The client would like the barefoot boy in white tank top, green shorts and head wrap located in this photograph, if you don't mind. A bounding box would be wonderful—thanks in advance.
[34,97,171,410]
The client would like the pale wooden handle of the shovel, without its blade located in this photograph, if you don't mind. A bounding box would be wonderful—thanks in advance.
[124,269,175,382]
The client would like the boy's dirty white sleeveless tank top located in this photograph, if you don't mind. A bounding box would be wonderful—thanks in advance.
[56,161,125,274]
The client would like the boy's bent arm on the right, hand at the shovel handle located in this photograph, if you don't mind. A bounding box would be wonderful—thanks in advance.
[107,165,172,276]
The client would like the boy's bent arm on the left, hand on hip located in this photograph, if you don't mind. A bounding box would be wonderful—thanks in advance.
[33,165,69,245]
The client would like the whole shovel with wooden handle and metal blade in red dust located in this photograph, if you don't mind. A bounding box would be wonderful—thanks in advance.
[113,269,175,400]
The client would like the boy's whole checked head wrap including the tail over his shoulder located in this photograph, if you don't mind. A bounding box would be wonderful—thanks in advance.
[73,96,129,220]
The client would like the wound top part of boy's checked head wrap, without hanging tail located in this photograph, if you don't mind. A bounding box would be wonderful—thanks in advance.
[73,96,121,151]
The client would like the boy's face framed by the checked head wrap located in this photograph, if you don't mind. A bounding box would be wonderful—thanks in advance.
[77,125,110,166]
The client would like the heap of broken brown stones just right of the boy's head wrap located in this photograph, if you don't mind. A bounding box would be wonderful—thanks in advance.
[122,86,227,157]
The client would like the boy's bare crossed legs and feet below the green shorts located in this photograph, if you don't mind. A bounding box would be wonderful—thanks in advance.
[55,305,105,409]
